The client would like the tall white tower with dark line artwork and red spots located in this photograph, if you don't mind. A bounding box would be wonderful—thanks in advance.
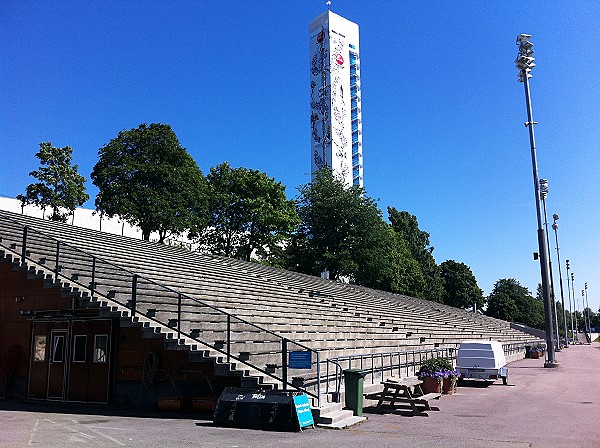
[309,10,363,187]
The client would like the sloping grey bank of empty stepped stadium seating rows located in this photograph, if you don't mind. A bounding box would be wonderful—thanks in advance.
[0,208,528,386]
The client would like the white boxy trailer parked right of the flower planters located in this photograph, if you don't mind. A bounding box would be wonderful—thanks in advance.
[456,340,508,385]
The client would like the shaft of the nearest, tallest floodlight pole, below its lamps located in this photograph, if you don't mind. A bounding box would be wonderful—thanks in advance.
[523,65,558,367]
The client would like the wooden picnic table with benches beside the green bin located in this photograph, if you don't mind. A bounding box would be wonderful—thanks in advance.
[374,377,442,414]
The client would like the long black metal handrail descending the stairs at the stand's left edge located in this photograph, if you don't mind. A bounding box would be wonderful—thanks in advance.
[0,213,321,406]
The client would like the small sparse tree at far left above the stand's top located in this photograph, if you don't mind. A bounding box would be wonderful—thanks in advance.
[17,142,90,222]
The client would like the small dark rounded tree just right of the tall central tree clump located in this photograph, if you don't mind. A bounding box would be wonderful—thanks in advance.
[440,260,485,309]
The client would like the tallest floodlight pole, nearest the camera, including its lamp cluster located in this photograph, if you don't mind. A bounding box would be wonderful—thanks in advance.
[515,34,558,367]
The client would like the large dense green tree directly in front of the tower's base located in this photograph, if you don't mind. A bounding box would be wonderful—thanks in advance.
[286,169,423,293]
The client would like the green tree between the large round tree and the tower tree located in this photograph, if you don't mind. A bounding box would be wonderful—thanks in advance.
[197,162,299,261]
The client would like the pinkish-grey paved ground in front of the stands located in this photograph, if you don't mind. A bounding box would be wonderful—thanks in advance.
[0,343,600,448]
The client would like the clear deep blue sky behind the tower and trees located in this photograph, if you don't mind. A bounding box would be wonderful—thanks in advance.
[0,0,600,316]
